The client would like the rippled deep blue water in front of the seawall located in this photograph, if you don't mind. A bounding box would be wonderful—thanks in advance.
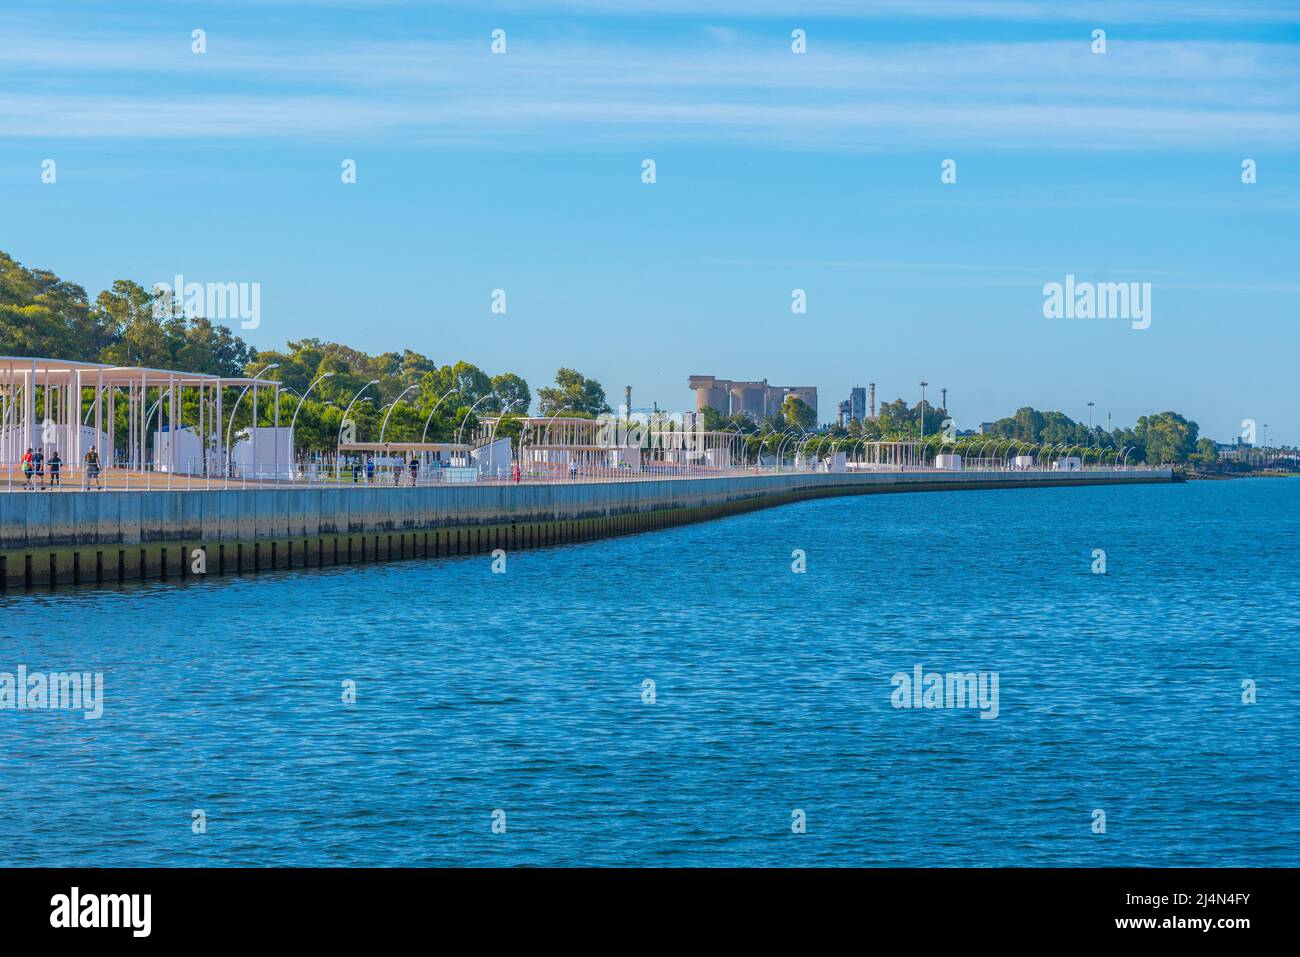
[0,480,1300,866]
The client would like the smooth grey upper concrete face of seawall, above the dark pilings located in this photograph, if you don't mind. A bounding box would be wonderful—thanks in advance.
[0,469,1173,551]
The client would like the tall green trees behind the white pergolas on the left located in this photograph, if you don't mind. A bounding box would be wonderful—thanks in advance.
[0,252,610,452]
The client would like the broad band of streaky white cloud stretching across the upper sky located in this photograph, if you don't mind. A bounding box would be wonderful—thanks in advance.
[0,27,1300,151]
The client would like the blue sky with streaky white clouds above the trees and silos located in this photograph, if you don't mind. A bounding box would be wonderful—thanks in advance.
[0,0,1300,443]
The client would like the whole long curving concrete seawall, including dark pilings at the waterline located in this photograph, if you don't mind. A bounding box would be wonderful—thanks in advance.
[0,469,1173,589]
